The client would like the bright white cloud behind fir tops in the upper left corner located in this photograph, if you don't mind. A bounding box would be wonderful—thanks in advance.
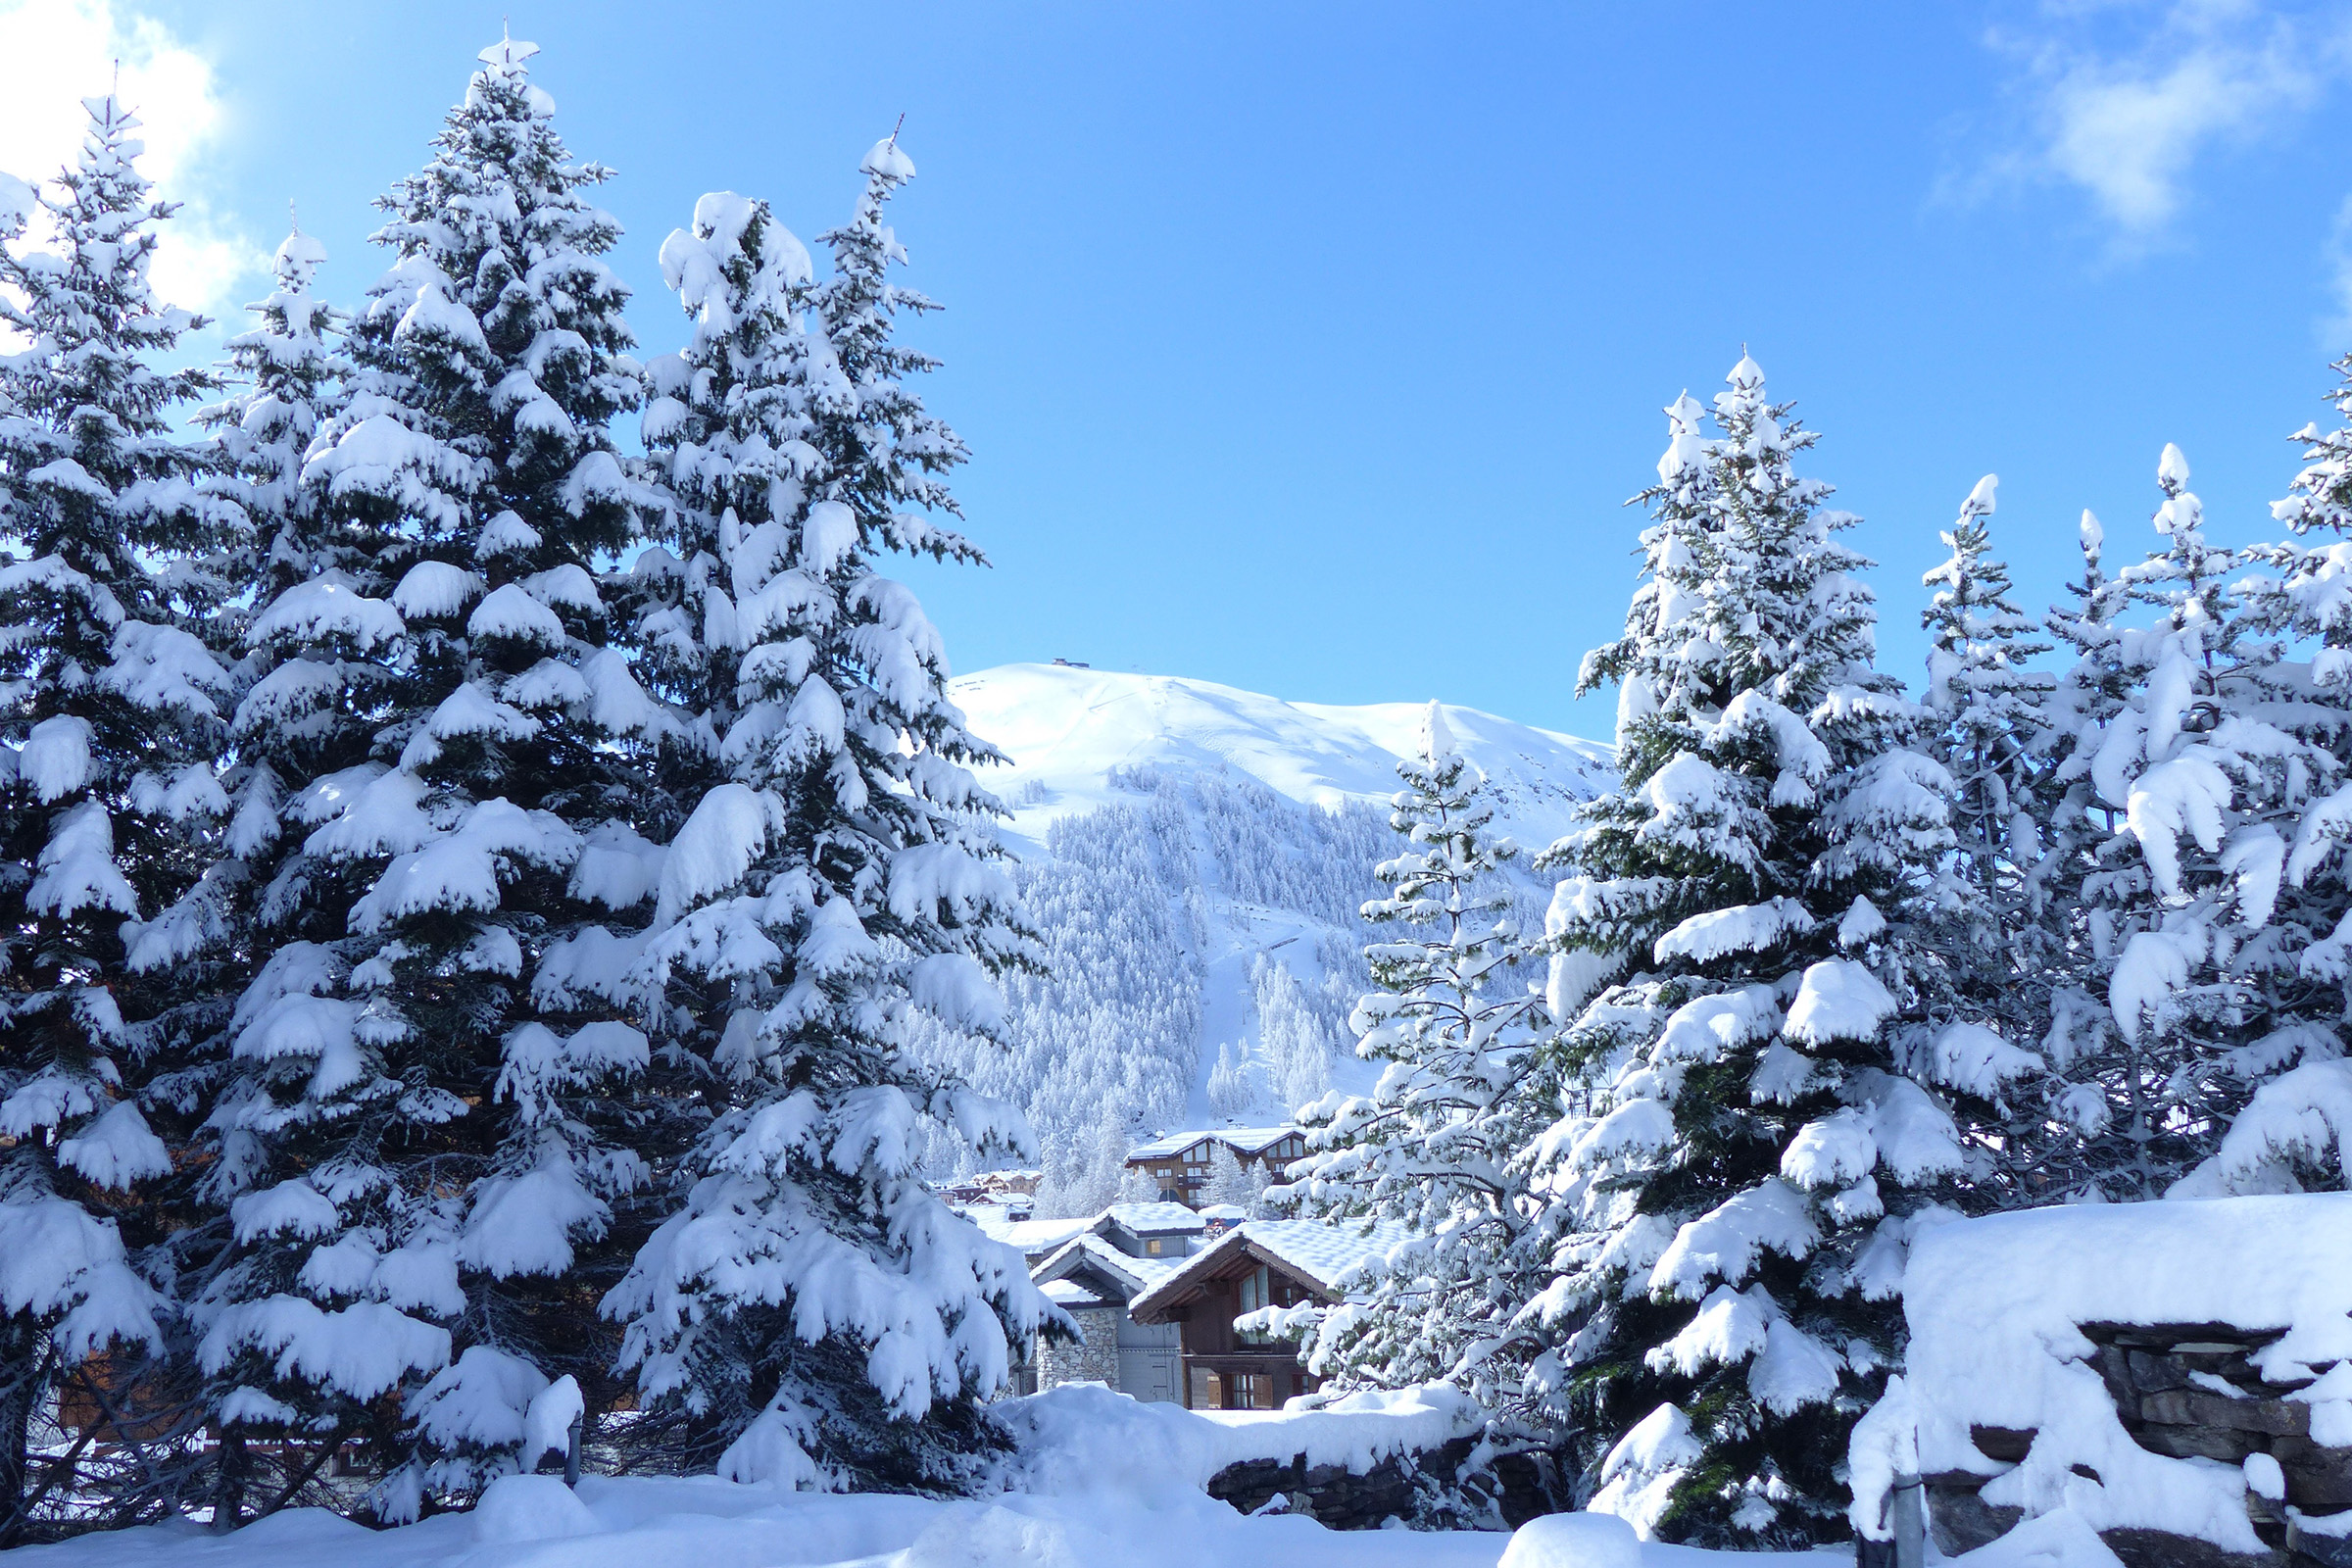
[0,0,269,315]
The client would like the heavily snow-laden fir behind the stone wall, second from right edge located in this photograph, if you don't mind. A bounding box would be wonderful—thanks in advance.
[2044,447,2345,1197]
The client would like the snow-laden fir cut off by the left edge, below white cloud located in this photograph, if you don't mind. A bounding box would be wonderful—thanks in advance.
[0,96,235,1535]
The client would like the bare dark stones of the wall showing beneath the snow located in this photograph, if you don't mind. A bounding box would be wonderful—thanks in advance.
[1927,1324,2352,1568]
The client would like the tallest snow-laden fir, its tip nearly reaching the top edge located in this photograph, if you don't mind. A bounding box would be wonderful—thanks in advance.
[200,40,677,1519]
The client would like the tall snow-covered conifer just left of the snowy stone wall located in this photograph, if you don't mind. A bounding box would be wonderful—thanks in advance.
[1529,358,1964,1544]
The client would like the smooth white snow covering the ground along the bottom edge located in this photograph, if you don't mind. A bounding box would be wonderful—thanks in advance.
[5,1385,1823,1568]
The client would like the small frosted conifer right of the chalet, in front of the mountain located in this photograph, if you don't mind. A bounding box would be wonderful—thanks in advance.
[1272,703,1557,1441]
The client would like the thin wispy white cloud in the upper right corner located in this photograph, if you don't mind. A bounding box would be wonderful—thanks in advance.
[1992,0,2352,252]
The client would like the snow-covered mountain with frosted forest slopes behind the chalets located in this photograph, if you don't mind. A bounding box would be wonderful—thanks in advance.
[921,665,1609,1201]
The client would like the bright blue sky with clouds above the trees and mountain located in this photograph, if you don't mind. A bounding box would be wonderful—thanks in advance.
[0,0,2352,736]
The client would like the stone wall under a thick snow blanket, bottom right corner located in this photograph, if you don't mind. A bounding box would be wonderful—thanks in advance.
[1856,1195,2352,1568]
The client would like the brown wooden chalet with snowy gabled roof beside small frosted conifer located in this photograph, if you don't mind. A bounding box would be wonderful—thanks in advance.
[1127,1220,1404,1410]
